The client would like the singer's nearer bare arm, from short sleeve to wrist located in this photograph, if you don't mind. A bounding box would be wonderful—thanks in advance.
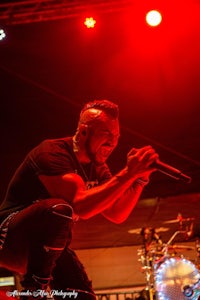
[39,169,133,219]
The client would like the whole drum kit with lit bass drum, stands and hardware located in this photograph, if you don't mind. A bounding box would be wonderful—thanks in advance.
[138,216,200,300]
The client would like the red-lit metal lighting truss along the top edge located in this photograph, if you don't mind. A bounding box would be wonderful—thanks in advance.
[0,0,132,26]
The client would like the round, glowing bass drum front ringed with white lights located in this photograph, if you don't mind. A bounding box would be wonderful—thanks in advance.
[154,257,200,300]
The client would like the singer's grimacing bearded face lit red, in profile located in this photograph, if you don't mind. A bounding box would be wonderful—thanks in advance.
[85,112,119,164]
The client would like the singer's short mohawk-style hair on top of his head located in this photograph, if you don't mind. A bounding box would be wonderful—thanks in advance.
[80,100,119,119]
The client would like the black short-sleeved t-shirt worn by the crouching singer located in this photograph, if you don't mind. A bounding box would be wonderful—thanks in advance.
[0,137,111,216]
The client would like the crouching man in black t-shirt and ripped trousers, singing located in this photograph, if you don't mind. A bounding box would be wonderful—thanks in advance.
[0,100,158,300]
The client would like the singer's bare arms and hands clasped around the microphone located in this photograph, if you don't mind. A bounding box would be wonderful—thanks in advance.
[39,146,157,223]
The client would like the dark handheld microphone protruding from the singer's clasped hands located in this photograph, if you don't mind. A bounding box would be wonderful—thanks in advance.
[151,159,192,183]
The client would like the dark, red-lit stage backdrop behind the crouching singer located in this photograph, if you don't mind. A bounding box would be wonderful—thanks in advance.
[0,0,200,248]
